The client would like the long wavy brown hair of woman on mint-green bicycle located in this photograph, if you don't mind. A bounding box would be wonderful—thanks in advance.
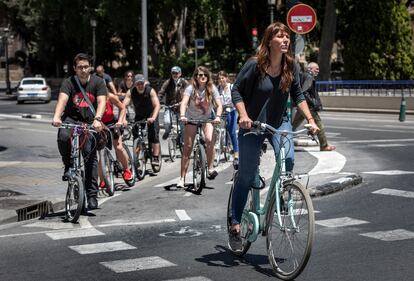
[254,22,294,93]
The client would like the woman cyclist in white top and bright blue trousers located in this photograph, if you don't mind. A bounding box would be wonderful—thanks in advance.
[218,70,239,163]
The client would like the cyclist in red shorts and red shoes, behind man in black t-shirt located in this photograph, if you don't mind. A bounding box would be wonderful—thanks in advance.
[99,93,133,188]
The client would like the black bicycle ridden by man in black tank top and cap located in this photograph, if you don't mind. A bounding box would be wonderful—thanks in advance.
[132,120,162,180]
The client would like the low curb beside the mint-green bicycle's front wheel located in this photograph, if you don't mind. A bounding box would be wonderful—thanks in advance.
[309,174,362,197]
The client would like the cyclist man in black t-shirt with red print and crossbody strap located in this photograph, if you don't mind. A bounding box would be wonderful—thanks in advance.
[52,53,107,209]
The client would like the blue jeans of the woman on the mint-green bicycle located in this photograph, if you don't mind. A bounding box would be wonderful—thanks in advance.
[231,119,294,224]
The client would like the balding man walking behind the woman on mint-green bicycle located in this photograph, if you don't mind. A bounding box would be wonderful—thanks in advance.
[292,62,336,151]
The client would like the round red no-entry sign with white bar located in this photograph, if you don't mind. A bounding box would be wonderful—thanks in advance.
[286,4,316,34]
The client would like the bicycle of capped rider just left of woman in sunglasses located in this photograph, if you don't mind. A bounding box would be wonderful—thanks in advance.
[165,103,183,162]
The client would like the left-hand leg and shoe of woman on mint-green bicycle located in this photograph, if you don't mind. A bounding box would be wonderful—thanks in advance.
[229,129,265,250]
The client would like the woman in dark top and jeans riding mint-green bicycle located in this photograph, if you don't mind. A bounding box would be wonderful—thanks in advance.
[229,22,319,251]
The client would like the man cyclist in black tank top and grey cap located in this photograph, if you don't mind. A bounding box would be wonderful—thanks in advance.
[123,74,161,165]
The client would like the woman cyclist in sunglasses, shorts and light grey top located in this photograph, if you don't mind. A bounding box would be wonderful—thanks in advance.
[177,66,223,188]
